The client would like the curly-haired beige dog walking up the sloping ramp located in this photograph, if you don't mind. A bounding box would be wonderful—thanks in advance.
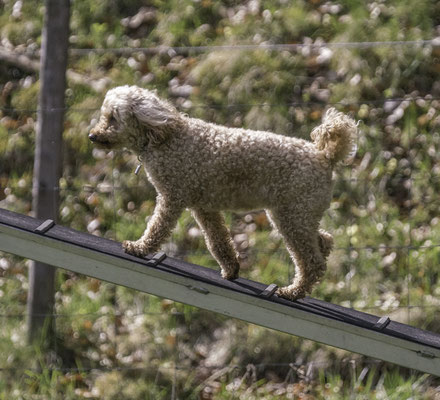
[89,86,357,300]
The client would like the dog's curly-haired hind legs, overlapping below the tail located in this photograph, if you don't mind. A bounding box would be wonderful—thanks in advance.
[267,207,326,300]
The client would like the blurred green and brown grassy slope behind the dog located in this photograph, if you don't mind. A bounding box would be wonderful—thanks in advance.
[0,0,440,399]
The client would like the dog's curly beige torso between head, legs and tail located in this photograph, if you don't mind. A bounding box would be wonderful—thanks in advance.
[146,118,332,210]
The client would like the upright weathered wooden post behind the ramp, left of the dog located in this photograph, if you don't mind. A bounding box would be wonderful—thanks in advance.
[28,0,70,343]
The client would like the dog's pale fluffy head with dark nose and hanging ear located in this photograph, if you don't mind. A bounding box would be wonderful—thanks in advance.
[89,86,181,151]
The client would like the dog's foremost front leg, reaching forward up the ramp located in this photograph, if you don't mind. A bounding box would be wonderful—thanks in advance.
[122,196,183,257]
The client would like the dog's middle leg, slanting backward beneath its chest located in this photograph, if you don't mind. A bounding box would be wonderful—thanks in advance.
[192,209,240,280]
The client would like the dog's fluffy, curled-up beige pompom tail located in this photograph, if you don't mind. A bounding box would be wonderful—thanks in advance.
[310,108,357,164]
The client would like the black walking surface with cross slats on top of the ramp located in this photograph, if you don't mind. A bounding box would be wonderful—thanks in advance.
[0,209,440,349]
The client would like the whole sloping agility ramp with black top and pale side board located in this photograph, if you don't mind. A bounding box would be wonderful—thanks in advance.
[0,209,440,376]
